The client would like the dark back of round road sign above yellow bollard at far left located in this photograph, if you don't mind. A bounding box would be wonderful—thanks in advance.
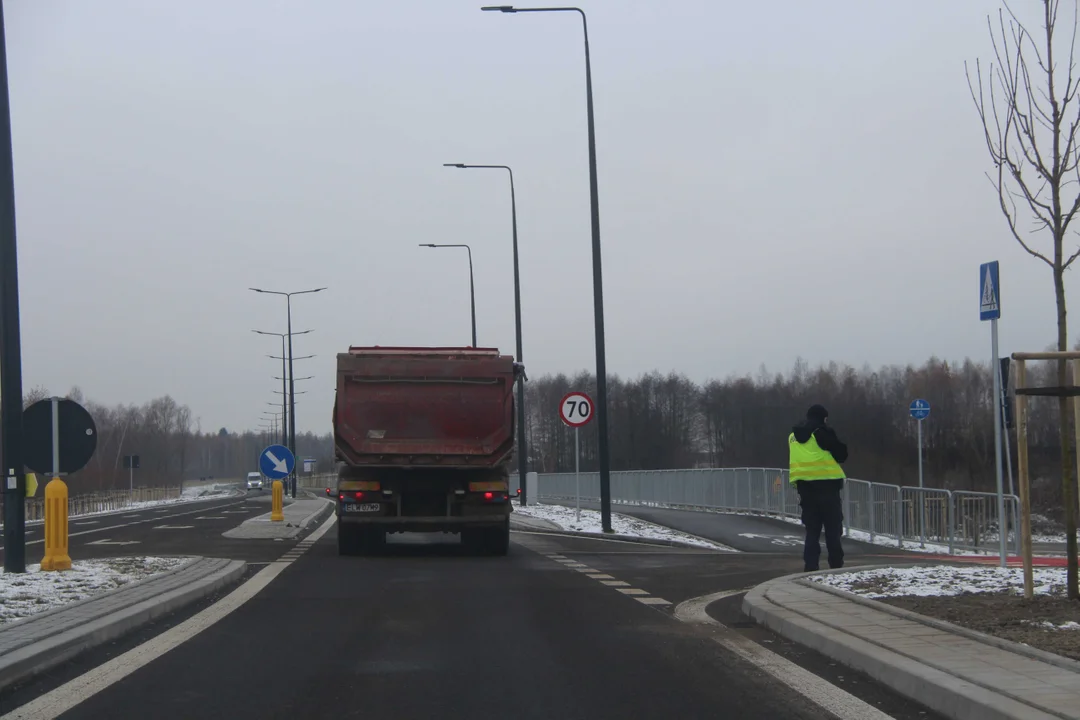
[23,398,97,475]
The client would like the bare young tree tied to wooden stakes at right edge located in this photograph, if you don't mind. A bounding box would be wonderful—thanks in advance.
[966,0,1080,599]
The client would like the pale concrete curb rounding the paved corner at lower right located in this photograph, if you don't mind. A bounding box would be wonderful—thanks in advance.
[742,566,1066,720]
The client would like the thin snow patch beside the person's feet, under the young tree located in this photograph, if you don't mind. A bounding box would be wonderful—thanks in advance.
[810,565,1066,598]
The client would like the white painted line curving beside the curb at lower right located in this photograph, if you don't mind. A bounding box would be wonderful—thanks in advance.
[673,587,893,720]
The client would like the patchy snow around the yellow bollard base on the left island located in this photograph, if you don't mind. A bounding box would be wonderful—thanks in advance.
[0,557,193,626]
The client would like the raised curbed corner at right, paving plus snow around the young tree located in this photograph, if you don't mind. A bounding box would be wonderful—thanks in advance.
[743,565,1080,720]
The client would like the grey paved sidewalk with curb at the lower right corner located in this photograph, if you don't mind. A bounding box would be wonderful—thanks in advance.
[743,568,1080,720]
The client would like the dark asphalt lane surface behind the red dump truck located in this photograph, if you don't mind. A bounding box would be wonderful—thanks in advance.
[0,528,936,720]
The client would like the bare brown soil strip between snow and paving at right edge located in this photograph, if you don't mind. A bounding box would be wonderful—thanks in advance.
[876,593,1080,661]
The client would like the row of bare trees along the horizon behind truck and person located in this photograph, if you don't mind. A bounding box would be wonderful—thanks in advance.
[25,351,1061,508]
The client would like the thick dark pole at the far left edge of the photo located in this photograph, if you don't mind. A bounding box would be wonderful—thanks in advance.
[0,2,26,572]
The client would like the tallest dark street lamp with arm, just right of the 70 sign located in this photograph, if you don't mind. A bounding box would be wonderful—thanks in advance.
[481,5,612,532]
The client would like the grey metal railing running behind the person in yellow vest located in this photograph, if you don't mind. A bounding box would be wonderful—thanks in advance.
[538,467,1020,554]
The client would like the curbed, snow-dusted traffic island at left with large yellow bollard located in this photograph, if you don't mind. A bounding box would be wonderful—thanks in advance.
[0,557,246,691]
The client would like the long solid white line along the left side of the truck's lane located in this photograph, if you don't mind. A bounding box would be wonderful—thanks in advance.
[0,515,337,720]
